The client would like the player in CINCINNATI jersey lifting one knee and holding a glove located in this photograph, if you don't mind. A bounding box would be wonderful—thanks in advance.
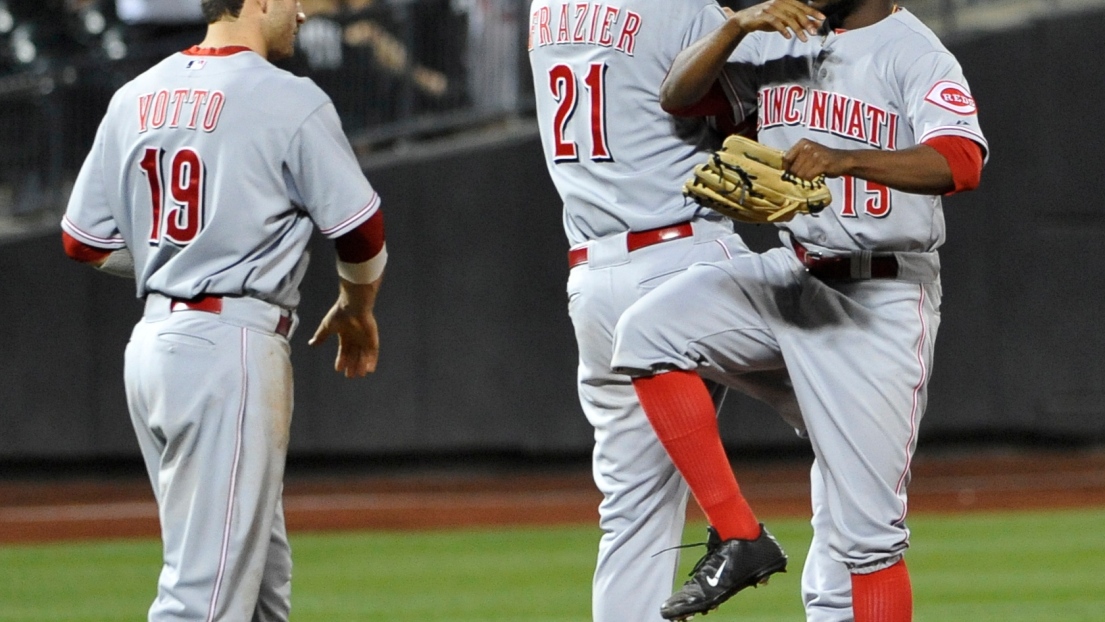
[612,0,988,622]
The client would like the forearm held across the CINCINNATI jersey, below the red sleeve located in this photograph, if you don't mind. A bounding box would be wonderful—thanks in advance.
[840,145,955,194]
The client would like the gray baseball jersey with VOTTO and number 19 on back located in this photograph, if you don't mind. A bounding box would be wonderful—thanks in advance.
[62,51,380,309]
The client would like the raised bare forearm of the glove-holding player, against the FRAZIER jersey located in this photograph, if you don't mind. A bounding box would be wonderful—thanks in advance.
[660,19,745,113]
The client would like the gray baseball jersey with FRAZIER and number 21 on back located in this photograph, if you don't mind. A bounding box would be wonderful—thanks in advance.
[529,0,724,245]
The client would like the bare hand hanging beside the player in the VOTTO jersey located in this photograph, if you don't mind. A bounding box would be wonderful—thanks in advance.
[307,281,380,378]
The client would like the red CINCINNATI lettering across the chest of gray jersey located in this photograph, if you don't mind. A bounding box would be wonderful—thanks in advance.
[757,84,898,150]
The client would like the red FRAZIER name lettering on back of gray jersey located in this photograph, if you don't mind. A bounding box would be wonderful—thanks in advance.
[527,2,641,56]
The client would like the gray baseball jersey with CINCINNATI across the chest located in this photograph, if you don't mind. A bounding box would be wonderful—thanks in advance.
[723,10,987,252]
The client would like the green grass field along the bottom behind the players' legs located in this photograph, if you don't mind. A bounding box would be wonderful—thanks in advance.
[0,508,1105,622]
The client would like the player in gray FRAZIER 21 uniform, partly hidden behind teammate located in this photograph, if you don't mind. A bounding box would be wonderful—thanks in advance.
[528,0,797,622]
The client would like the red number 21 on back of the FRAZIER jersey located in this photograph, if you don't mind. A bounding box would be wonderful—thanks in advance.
[549,63,614,164]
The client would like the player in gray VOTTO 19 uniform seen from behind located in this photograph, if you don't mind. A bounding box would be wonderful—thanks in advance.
[62,0,387,622]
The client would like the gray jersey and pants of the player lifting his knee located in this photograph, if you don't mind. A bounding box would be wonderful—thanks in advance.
[612,11,986,622]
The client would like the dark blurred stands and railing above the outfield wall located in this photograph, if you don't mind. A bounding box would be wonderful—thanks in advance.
[0,0,1105,240]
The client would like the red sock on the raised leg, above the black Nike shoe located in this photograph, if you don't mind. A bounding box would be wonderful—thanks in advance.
[633,371,760,540]
